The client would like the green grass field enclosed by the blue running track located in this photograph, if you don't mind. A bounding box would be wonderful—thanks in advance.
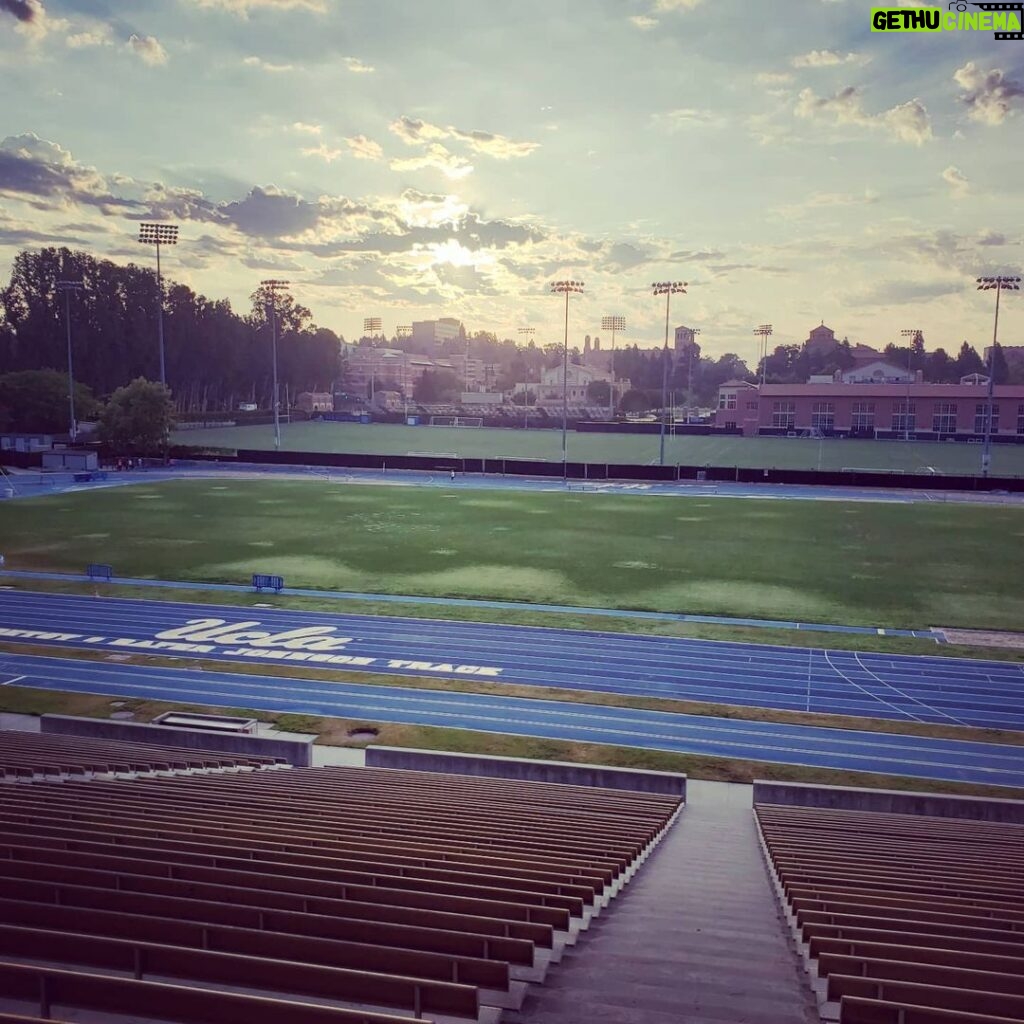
[0,479,1024,630]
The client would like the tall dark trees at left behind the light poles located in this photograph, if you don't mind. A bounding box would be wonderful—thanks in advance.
[0,248,341,413]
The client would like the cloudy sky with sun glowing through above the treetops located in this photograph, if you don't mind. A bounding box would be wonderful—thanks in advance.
[0,0,1024,364]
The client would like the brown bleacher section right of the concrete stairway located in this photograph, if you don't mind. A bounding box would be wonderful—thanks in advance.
[755,804,1024,1024]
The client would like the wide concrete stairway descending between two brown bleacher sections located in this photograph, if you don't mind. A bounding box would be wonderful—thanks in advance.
[512,781,819,1024]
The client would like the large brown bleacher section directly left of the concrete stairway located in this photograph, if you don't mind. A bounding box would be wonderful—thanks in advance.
[0,737,681,1024]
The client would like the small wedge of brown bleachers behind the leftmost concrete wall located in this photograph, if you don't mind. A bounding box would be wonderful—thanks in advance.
[0,731,284,781]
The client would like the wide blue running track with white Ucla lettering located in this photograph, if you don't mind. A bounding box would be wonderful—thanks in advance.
[0,591,1024,733]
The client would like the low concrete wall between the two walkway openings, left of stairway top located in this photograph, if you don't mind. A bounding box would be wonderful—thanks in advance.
[367,746,686,800]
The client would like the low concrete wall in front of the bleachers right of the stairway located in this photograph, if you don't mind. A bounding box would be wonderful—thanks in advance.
[754,780,1024,824]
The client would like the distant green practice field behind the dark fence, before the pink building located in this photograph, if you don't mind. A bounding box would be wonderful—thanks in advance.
[174,423,1024,476]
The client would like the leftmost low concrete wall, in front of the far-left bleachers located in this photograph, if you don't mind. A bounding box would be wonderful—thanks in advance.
[40,715,312,768]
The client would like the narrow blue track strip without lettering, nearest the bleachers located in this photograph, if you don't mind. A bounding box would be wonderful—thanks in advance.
[0,654,1024,786]
